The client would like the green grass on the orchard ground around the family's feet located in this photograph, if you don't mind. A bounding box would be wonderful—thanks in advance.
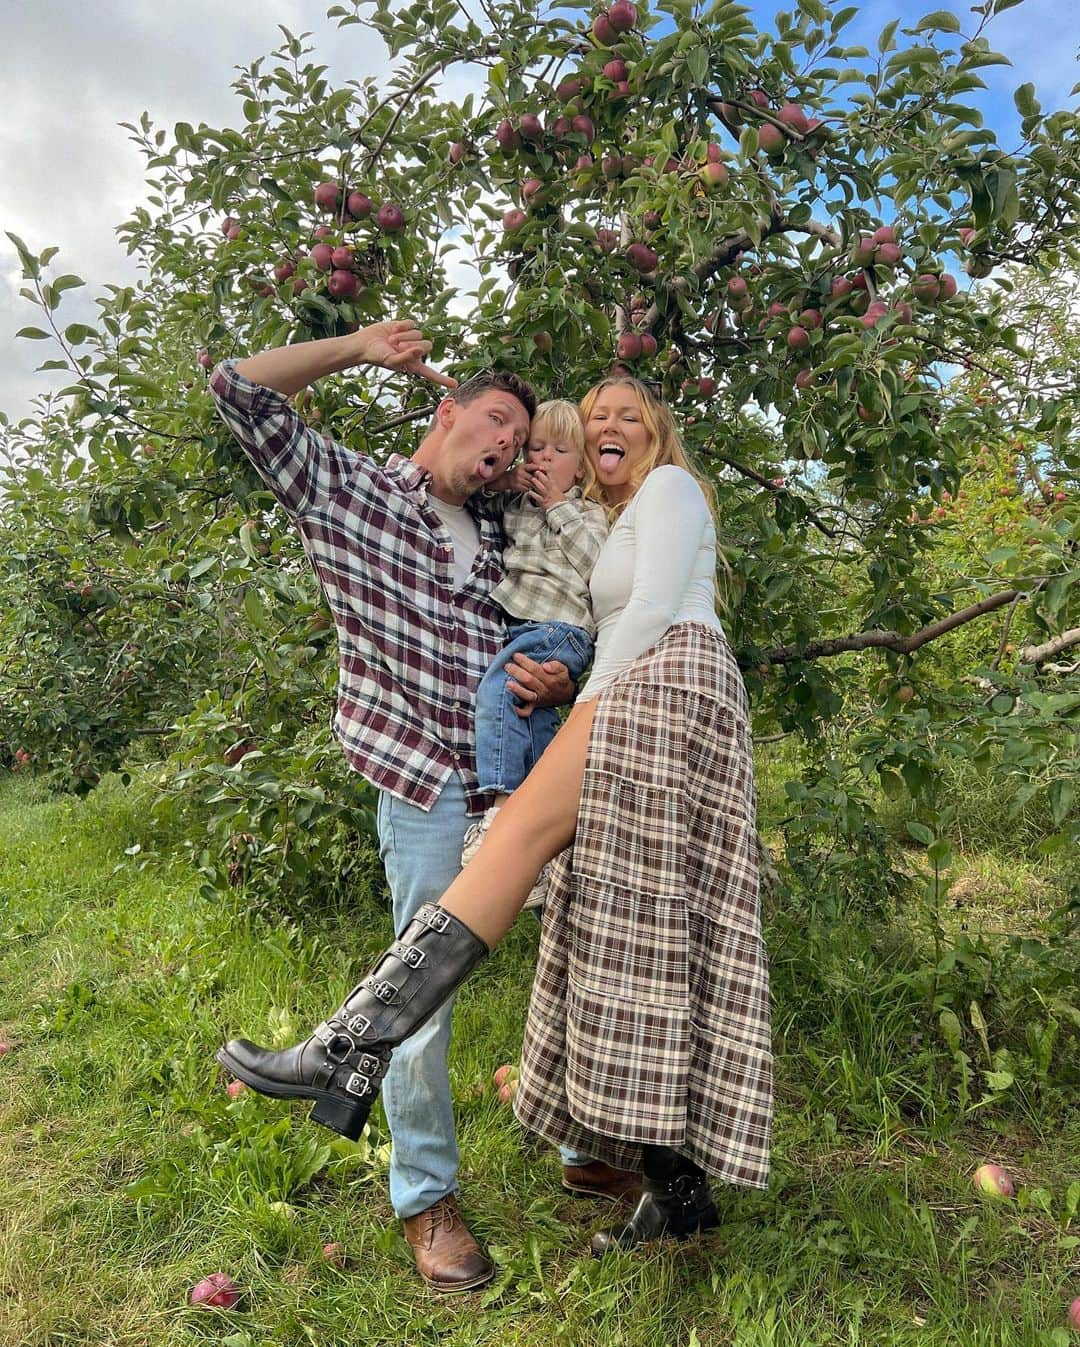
[0,780,1080,1347]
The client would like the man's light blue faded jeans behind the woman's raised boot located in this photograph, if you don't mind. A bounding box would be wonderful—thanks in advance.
[378,776,587,1220]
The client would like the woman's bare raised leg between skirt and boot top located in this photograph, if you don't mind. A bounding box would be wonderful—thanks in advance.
[440,702,597,950]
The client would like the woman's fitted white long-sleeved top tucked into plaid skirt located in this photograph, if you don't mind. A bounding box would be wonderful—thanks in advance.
[578,465,723,702]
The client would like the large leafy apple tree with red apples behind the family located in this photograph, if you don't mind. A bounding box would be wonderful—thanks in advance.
[0,0,1080,905]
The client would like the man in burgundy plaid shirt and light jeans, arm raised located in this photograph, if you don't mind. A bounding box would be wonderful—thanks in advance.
[210,319,597,1292]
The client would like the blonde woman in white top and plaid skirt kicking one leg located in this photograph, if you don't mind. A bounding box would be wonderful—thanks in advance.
[218,377,772,1254]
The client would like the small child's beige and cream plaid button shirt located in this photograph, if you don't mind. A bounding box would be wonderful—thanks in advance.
[494,486,607,636]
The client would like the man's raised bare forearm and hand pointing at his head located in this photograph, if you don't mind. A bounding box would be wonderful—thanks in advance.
[236,318,458,397]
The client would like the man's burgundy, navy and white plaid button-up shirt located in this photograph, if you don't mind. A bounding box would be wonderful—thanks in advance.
[210,364,506,814]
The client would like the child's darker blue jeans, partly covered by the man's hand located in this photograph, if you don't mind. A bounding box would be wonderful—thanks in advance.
[477,622,593,795]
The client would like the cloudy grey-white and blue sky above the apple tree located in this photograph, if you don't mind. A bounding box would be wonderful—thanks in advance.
[0,0,1080,419]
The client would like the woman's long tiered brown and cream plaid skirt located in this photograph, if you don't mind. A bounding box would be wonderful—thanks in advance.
[514,622,773,1188]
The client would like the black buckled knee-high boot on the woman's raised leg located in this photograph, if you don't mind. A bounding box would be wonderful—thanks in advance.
[217,904,489,1141]
